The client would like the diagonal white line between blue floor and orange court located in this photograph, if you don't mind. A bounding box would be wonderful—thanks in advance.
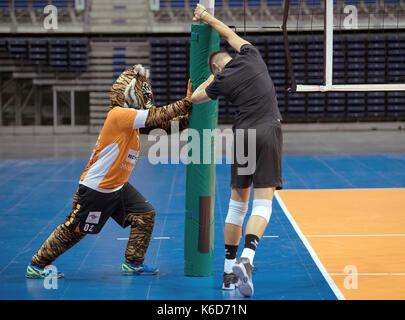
[274,191,346,300]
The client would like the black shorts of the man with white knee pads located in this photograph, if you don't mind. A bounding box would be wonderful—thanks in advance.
[231,123,283,190]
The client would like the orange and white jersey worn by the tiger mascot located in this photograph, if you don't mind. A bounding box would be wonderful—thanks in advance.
[80,107,148,192]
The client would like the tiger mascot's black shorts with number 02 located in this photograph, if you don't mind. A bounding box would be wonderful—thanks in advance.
[65,182,154,234]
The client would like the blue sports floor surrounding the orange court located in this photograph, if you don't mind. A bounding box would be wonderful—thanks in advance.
[0,155,405,300]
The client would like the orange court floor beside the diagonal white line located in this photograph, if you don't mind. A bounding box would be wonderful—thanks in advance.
[278,188,405,300]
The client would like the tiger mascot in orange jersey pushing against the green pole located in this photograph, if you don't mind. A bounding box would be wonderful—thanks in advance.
[26,65,192,279]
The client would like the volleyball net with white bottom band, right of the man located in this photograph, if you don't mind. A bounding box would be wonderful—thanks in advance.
[281,0,405,92]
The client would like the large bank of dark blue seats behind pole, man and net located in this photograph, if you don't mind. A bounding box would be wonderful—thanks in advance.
[150,33,405,122]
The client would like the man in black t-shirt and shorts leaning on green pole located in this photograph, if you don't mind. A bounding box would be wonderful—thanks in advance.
[192,4,282,297]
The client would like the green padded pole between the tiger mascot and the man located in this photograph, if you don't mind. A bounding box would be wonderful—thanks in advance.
[184,23,219,277]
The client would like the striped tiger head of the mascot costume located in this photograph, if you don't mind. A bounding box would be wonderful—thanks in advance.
[110,64,153,109]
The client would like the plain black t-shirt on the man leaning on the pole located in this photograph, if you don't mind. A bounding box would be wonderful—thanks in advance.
[205,44,282,129]
